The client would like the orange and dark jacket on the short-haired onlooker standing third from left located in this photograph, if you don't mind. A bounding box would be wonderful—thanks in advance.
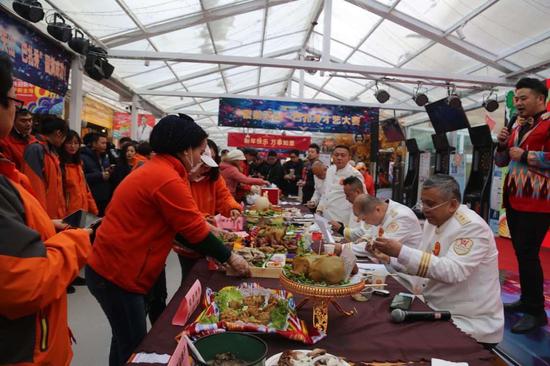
[22,142,66,219]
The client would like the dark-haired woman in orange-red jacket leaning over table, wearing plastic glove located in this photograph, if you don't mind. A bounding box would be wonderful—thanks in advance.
[86,115,250,366]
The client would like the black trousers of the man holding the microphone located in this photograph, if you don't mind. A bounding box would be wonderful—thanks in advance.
[506,205,550,316]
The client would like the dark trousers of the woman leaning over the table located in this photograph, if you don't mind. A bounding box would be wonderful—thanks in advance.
[86,266,147,366]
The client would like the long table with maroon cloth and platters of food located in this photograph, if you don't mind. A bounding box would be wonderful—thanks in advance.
[135,203,494,366]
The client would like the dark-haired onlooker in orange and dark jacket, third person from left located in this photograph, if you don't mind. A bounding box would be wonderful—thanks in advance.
[22,115,69,219]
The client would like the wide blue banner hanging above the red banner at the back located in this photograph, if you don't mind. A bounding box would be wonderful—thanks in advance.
[218,98,379,134]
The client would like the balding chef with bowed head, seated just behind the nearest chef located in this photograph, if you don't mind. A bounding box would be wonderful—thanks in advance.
[353,194,423,294]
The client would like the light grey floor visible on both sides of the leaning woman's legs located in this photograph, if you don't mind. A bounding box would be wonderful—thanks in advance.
[68,253,181,366]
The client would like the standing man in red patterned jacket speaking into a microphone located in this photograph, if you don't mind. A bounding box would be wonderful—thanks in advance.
[495,78,550,333]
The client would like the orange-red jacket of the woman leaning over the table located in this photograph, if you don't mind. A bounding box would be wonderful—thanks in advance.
[88,154,210,294]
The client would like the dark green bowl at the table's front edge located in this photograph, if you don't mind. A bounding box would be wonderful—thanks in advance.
[195,332,267,366]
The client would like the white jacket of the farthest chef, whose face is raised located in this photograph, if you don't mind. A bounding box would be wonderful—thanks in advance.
[317,164,366,223]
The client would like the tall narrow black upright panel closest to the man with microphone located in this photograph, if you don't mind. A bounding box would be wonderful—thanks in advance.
[463,125,494,221]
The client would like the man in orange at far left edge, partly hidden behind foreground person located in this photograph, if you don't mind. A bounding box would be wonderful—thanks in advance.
[0,109,37,169]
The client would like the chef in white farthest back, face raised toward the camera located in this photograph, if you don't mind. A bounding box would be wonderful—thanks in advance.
[317,145,365,223]
